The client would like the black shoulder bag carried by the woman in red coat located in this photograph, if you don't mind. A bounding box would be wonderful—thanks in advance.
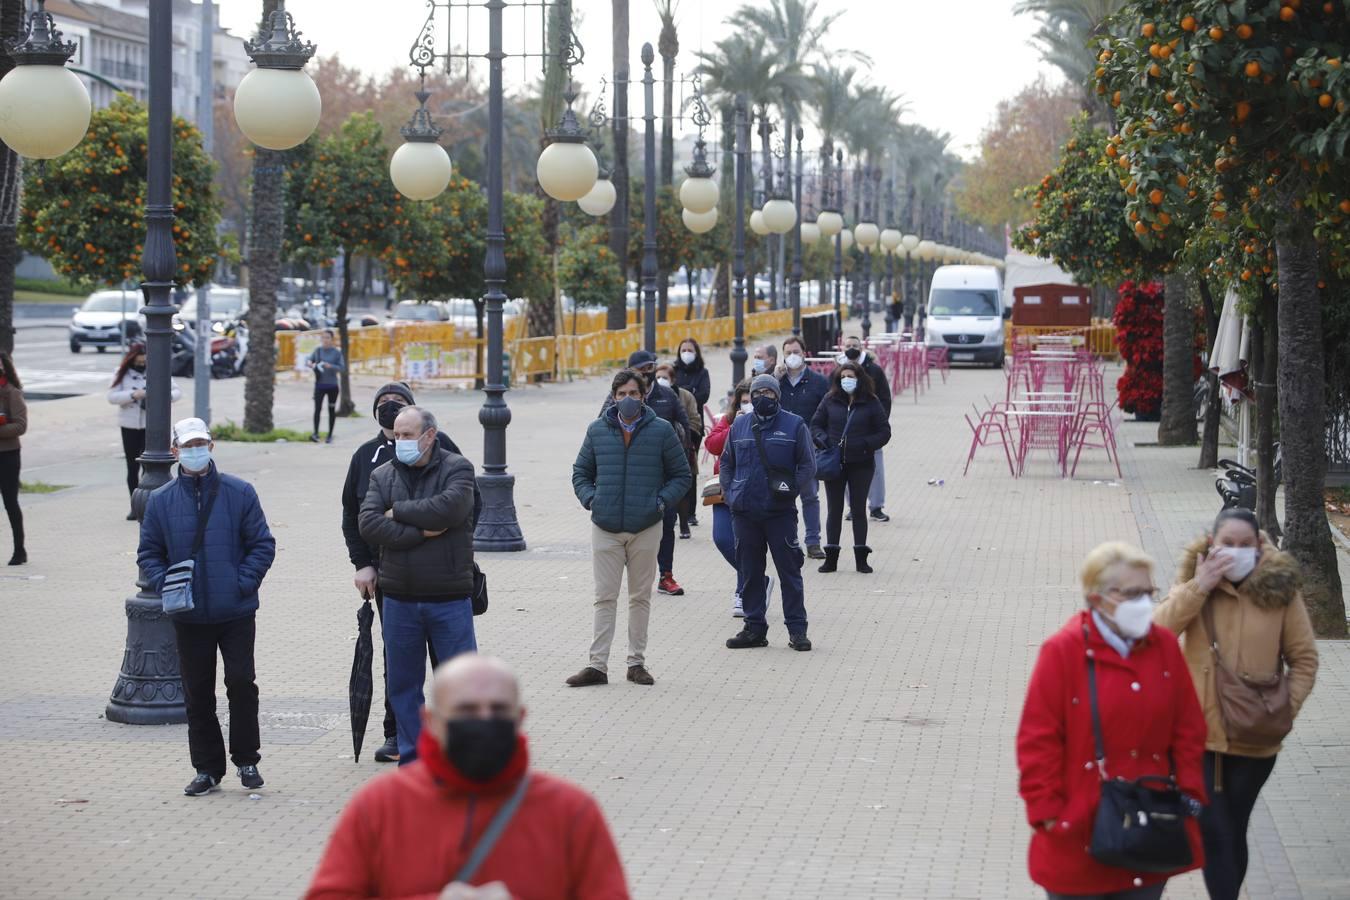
[1088,636,1193,872]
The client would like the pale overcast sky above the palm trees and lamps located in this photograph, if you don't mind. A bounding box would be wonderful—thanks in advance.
[219,0,1057,158]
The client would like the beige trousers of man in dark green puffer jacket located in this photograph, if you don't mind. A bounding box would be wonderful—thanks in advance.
[590,522,662,672]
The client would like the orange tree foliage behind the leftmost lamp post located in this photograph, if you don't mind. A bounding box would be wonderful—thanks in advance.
[19,94,220,285]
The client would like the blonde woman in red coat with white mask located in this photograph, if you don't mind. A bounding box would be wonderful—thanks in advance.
[1017,542,1206,900]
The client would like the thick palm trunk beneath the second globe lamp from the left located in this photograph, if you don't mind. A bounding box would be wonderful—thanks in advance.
[244,146,286,434]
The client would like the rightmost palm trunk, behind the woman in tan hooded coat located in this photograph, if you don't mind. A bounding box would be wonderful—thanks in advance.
[1276,203,1346,637]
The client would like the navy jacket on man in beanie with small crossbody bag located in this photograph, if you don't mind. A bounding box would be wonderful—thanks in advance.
[718,409,815,519]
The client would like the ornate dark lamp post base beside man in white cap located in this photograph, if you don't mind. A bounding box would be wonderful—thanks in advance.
[105,594,188,725]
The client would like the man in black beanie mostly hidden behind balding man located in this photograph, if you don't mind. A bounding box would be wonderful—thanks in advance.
[342,382,482,762]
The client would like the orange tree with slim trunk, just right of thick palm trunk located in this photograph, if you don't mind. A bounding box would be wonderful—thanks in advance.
[285,112,394,416]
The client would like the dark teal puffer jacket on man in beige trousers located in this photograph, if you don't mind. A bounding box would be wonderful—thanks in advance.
[572,406,693,534]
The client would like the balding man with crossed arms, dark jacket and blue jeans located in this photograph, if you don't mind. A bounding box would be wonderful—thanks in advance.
[359,406,478,765]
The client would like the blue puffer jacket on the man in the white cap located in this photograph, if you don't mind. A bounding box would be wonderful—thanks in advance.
[136,463,277,625]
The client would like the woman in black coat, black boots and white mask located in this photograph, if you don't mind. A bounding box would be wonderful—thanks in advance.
[811,362,891,572]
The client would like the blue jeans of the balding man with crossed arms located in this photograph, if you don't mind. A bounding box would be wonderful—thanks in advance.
[383,594,478,765]
